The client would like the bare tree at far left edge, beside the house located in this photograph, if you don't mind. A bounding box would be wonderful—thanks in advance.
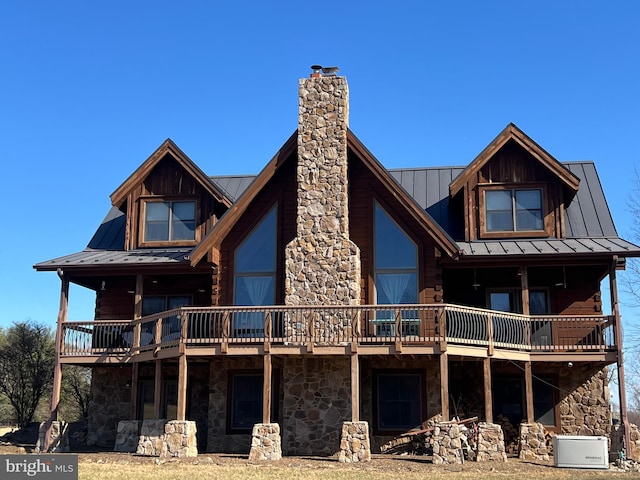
[0,322,55,427]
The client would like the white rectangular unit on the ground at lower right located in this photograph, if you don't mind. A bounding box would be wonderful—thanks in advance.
[553,435,609,469]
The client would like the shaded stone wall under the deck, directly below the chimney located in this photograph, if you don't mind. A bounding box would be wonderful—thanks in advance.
[282,357,351,455]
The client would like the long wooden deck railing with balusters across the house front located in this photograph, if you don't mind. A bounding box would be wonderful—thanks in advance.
[62,304,615,356]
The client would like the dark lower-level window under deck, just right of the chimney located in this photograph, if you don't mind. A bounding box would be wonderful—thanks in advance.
[375,372,424,432]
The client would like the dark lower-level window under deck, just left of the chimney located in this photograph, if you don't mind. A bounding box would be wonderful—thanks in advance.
[228,373,264,431]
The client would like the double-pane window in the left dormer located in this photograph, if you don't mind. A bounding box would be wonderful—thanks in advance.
[144,201,196,242]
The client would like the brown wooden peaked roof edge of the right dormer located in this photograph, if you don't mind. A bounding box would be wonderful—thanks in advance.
[449,123,580,197]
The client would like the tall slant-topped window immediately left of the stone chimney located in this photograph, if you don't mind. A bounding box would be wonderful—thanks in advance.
[233,206,277,337]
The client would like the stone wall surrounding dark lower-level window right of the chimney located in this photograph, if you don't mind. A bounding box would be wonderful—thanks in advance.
[360,357,442,453]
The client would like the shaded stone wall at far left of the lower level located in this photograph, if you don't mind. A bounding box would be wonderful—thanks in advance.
[87,366,131,450]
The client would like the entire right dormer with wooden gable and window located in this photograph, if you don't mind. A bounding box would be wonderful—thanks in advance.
[449,123,580,241]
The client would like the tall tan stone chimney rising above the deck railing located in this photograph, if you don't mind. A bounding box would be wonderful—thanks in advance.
[285,65,360,306]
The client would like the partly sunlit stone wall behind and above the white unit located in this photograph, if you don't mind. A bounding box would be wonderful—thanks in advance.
[559,365,611,436]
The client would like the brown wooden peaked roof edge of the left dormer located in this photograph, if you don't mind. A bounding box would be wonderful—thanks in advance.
[111,138,233,208]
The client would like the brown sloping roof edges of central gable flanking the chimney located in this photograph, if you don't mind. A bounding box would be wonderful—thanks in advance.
[190,130,458,265]
